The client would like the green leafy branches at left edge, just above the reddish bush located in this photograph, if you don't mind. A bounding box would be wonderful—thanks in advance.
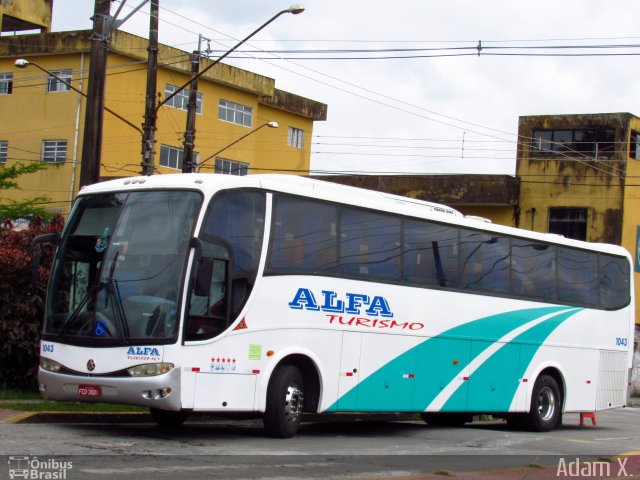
[0,162,54,223]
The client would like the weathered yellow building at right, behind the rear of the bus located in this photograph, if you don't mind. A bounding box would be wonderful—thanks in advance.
[516,113,640,332]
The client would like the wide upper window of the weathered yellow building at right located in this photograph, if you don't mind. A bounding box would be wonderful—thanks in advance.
[531,128,616,158]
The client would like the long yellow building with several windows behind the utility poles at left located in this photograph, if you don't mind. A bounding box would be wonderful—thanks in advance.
[0,29,327,214]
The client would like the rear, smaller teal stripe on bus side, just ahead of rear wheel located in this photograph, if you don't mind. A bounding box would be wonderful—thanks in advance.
[441,309,580,413]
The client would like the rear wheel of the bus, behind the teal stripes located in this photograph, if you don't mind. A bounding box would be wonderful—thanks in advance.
[526,375,562,432]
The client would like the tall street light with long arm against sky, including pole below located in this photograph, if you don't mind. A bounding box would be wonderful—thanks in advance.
[142,4,304,175]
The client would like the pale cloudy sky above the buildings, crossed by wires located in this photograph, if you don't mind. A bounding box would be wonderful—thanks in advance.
[47,0,640,174]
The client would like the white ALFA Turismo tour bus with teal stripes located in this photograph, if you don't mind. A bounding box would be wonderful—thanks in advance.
[34,174,634,437]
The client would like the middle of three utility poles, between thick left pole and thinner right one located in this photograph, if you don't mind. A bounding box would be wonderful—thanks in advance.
[141,0,160,175]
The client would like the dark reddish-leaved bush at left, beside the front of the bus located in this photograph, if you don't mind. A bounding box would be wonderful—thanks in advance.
[0,217,63,390]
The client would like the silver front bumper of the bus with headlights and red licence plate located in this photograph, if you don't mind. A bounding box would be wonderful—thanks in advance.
[38,368,181,411]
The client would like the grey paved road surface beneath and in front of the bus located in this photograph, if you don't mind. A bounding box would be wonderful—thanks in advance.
[0,408,640,480]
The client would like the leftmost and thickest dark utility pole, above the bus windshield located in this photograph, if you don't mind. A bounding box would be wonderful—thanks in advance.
[80,0,112,187]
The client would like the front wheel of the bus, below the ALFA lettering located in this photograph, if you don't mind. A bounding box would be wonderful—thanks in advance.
[263,365,304,438]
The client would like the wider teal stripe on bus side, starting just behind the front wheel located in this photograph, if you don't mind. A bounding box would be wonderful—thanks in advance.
[327,306,567,411]
